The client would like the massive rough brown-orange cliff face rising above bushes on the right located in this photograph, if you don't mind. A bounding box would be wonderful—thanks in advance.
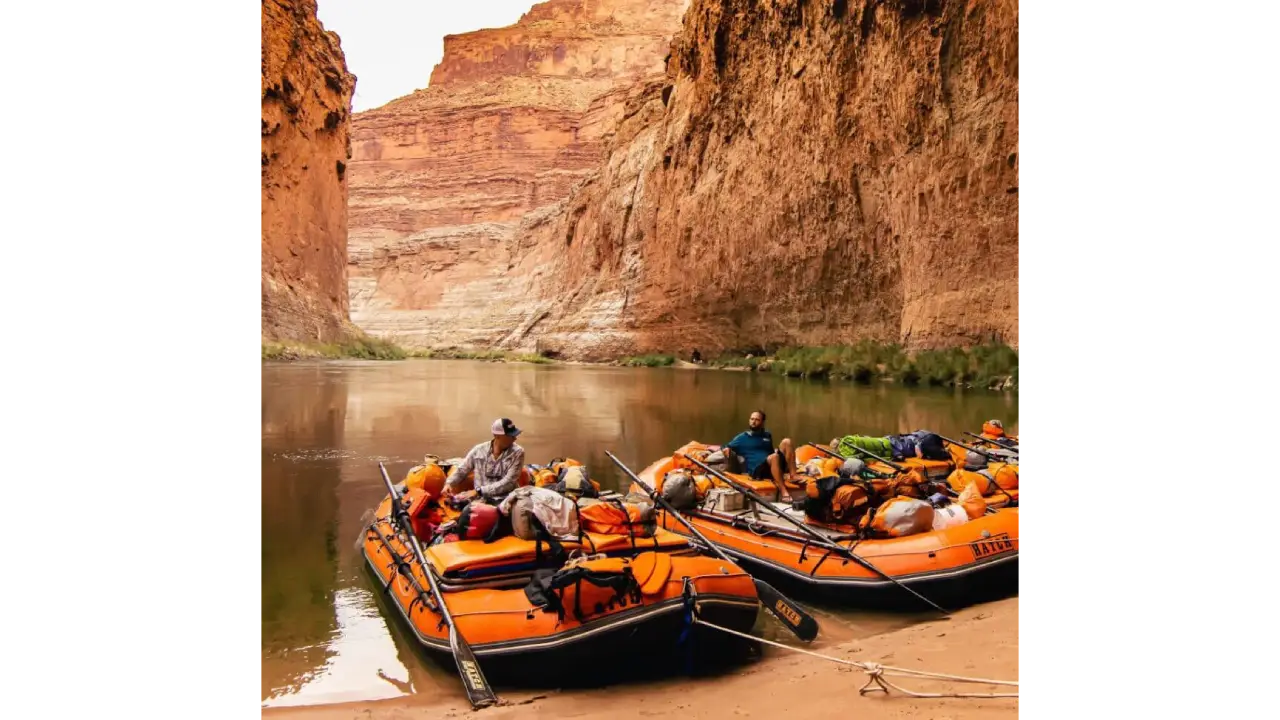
[509,0,1019,356]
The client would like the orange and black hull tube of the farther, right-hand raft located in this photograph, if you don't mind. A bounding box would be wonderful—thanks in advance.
[634,443,1021,610]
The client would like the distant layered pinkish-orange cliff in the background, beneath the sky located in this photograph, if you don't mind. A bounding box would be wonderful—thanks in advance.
[348,0,689,346]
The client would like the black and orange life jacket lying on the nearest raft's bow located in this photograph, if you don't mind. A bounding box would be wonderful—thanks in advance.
[525,552,671,623]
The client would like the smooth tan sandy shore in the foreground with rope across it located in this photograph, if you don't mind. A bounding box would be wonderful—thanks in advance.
[262,597,1021,720]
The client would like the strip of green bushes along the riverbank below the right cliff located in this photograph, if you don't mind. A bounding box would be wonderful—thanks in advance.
[708,341,1021,389]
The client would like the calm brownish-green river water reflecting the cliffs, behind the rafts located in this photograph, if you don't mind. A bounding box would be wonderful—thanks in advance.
[259,360,1020,707]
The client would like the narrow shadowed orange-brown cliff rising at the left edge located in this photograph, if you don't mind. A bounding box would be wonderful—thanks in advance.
[259,0,356,342]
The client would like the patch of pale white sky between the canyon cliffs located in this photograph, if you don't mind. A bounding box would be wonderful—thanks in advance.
[317,0,541,113]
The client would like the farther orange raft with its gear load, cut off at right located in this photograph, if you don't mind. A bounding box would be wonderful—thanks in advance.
[640,423,1021,610]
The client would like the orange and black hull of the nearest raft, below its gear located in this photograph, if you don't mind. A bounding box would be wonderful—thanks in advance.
[362,489,759,678]
